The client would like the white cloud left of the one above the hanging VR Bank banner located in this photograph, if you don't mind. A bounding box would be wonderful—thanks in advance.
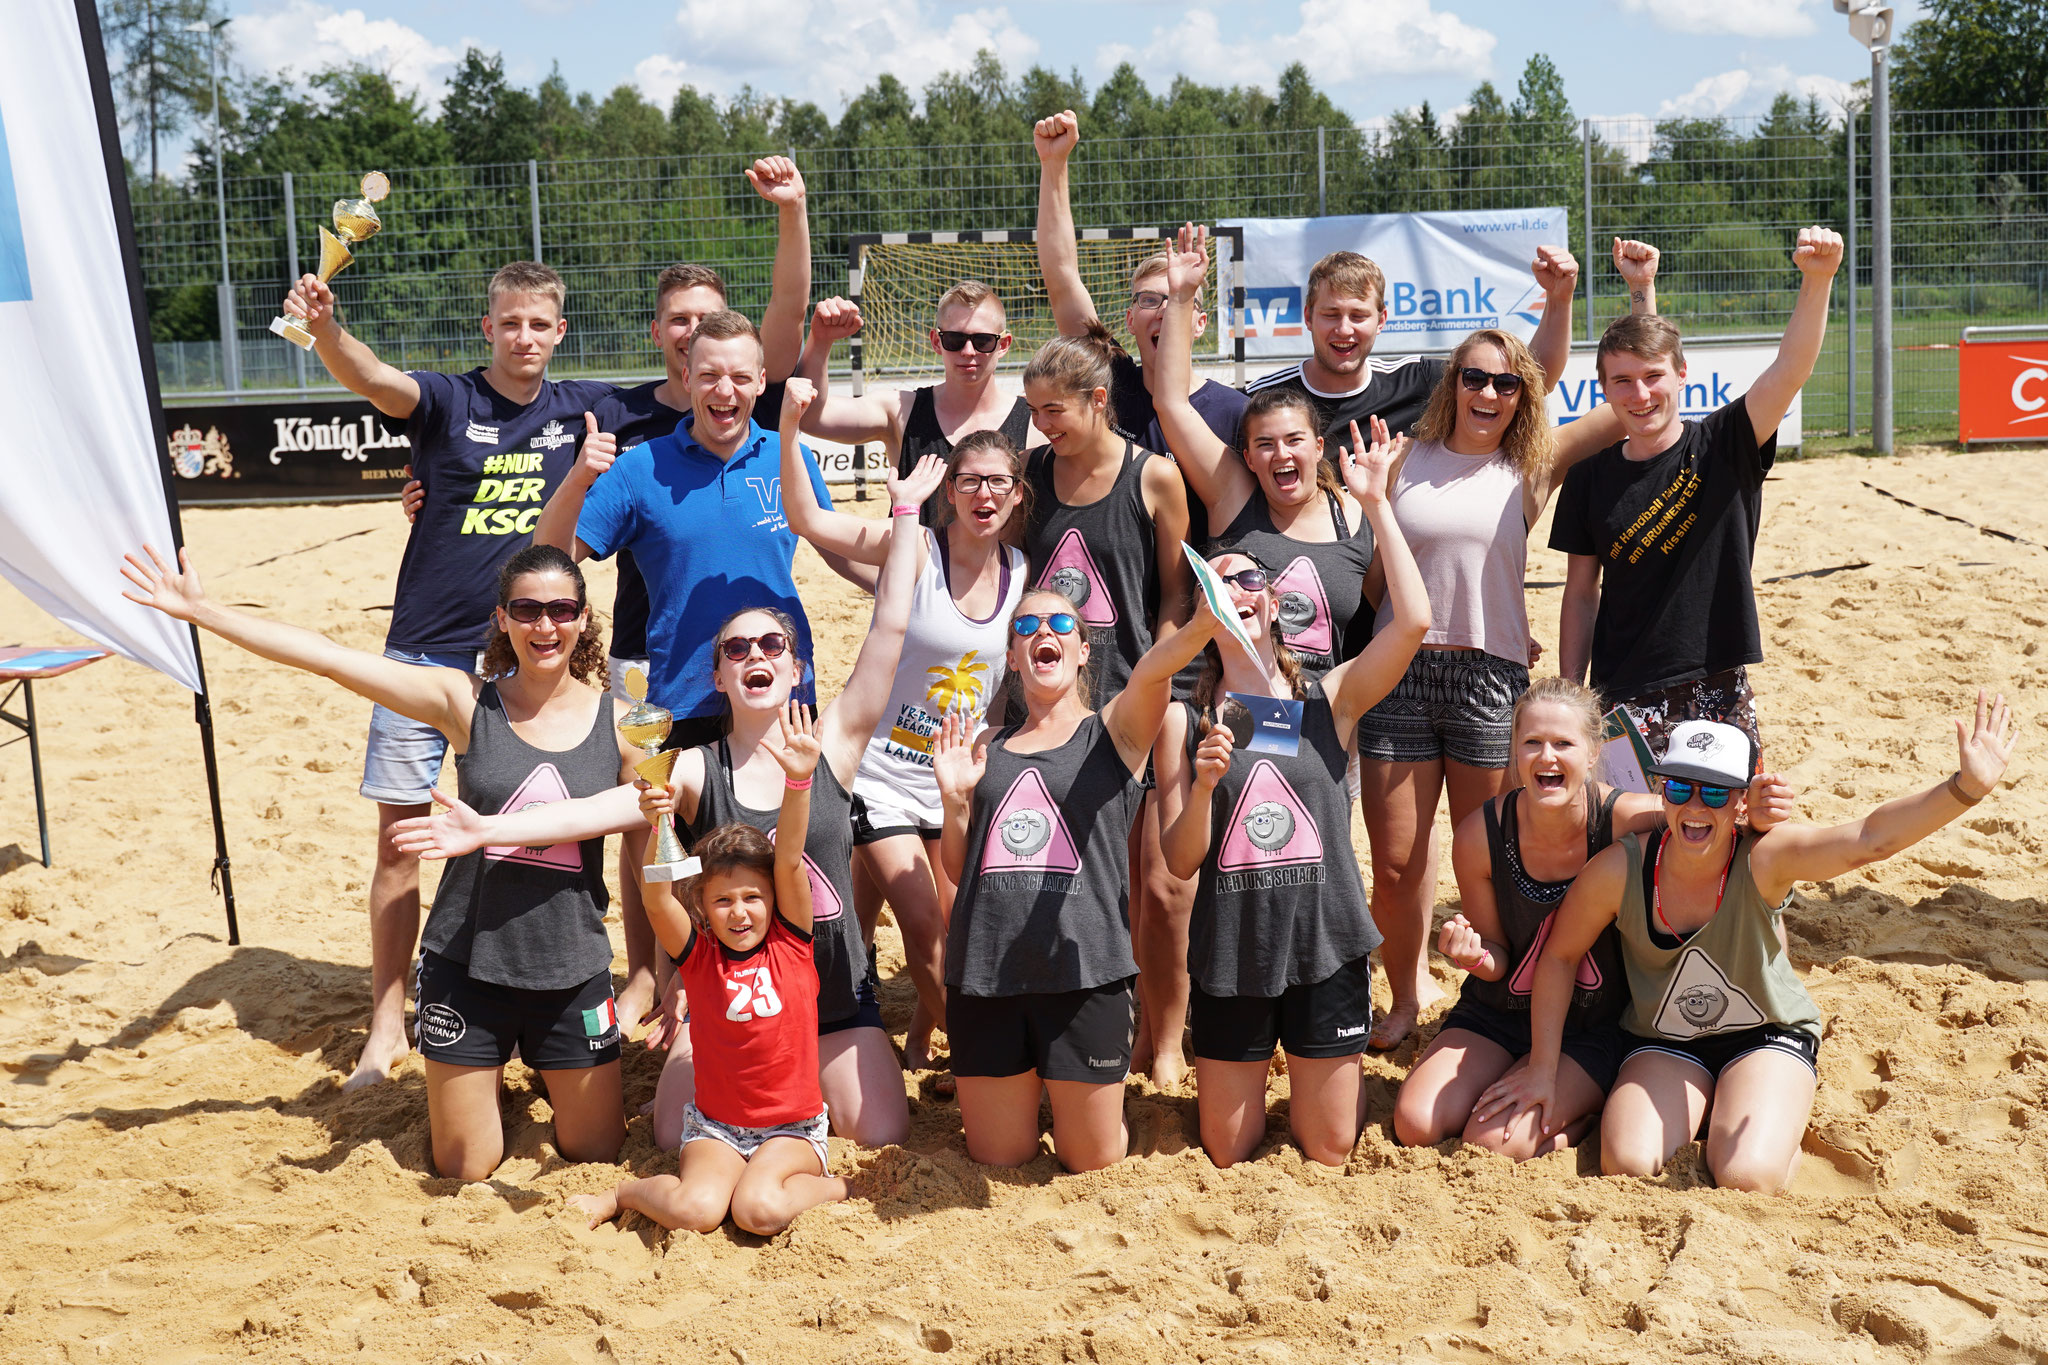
[655,0,1038,111]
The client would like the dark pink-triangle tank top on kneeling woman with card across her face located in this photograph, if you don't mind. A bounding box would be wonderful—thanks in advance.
[1184,681,1380,999]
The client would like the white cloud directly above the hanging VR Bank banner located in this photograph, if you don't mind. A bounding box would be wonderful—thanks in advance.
[1096,0,1497,90]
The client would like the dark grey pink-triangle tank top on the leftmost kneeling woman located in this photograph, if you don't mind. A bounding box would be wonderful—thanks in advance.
[420,684,618,990]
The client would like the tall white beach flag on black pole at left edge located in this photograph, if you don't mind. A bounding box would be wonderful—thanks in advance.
[0,0,199,692]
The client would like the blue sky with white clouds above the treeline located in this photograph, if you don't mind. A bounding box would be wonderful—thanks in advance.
[216,0,1919,145]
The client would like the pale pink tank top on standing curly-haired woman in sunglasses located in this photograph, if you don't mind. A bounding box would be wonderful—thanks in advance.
[1378,440,1530,665]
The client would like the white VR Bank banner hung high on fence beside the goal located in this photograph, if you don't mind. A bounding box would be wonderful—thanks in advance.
[1219,209,1565,358]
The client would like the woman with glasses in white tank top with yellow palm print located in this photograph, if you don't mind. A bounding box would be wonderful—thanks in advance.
[782,379,1030,1070]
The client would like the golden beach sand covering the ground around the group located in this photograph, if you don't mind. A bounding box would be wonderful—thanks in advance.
[0,450,2048,1365]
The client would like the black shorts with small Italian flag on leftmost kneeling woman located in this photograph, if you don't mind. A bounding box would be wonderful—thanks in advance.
[414,950,623,1070]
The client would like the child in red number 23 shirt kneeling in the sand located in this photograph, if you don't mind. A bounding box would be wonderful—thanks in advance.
[569,702,848,1236]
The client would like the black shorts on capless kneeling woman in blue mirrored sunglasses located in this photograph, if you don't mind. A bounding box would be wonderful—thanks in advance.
[946,976,1139,1085]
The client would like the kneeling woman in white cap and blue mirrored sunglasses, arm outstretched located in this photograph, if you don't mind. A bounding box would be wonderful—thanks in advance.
[1475,688,2019,1193]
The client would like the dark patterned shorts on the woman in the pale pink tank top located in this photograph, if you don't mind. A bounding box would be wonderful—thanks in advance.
[1358,649,1530,767]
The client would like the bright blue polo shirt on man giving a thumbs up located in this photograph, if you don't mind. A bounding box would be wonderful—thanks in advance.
[575,422,831,720]
